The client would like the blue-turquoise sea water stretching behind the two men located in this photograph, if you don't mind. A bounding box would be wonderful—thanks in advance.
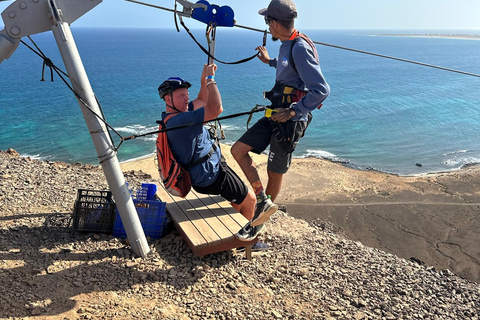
[0,28,480,175]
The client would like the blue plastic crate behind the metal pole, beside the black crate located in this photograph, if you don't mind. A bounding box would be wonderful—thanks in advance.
[112,199,170,239]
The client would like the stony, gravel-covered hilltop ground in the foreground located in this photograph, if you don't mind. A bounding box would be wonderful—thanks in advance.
[0,150,480,319]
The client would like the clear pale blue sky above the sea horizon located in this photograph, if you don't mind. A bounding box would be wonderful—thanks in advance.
[0,0,480,30]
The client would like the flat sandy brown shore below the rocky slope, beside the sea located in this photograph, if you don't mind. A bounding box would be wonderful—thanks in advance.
[122,145,480,282]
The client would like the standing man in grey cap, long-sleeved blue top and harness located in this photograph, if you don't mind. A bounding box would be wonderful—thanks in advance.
[231,0,330,229]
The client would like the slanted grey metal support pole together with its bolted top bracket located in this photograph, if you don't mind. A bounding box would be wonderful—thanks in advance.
[0,0,150,258]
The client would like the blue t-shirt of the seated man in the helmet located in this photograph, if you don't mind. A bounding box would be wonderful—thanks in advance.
[162,108,221,187]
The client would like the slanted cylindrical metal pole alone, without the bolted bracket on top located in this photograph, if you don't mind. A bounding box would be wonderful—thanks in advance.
[52,22,150,258]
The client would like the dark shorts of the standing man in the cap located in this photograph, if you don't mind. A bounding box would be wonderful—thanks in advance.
[238,116,311,174]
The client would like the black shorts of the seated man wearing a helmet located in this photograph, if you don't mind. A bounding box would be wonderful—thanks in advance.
[192,164,248,204]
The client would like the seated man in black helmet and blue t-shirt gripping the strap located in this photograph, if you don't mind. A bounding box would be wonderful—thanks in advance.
[158,64,262,241]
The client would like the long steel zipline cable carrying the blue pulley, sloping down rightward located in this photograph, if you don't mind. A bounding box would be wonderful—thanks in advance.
[124,0,480,78]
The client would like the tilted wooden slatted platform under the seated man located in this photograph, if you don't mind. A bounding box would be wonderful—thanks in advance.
[157,186,257,259]
